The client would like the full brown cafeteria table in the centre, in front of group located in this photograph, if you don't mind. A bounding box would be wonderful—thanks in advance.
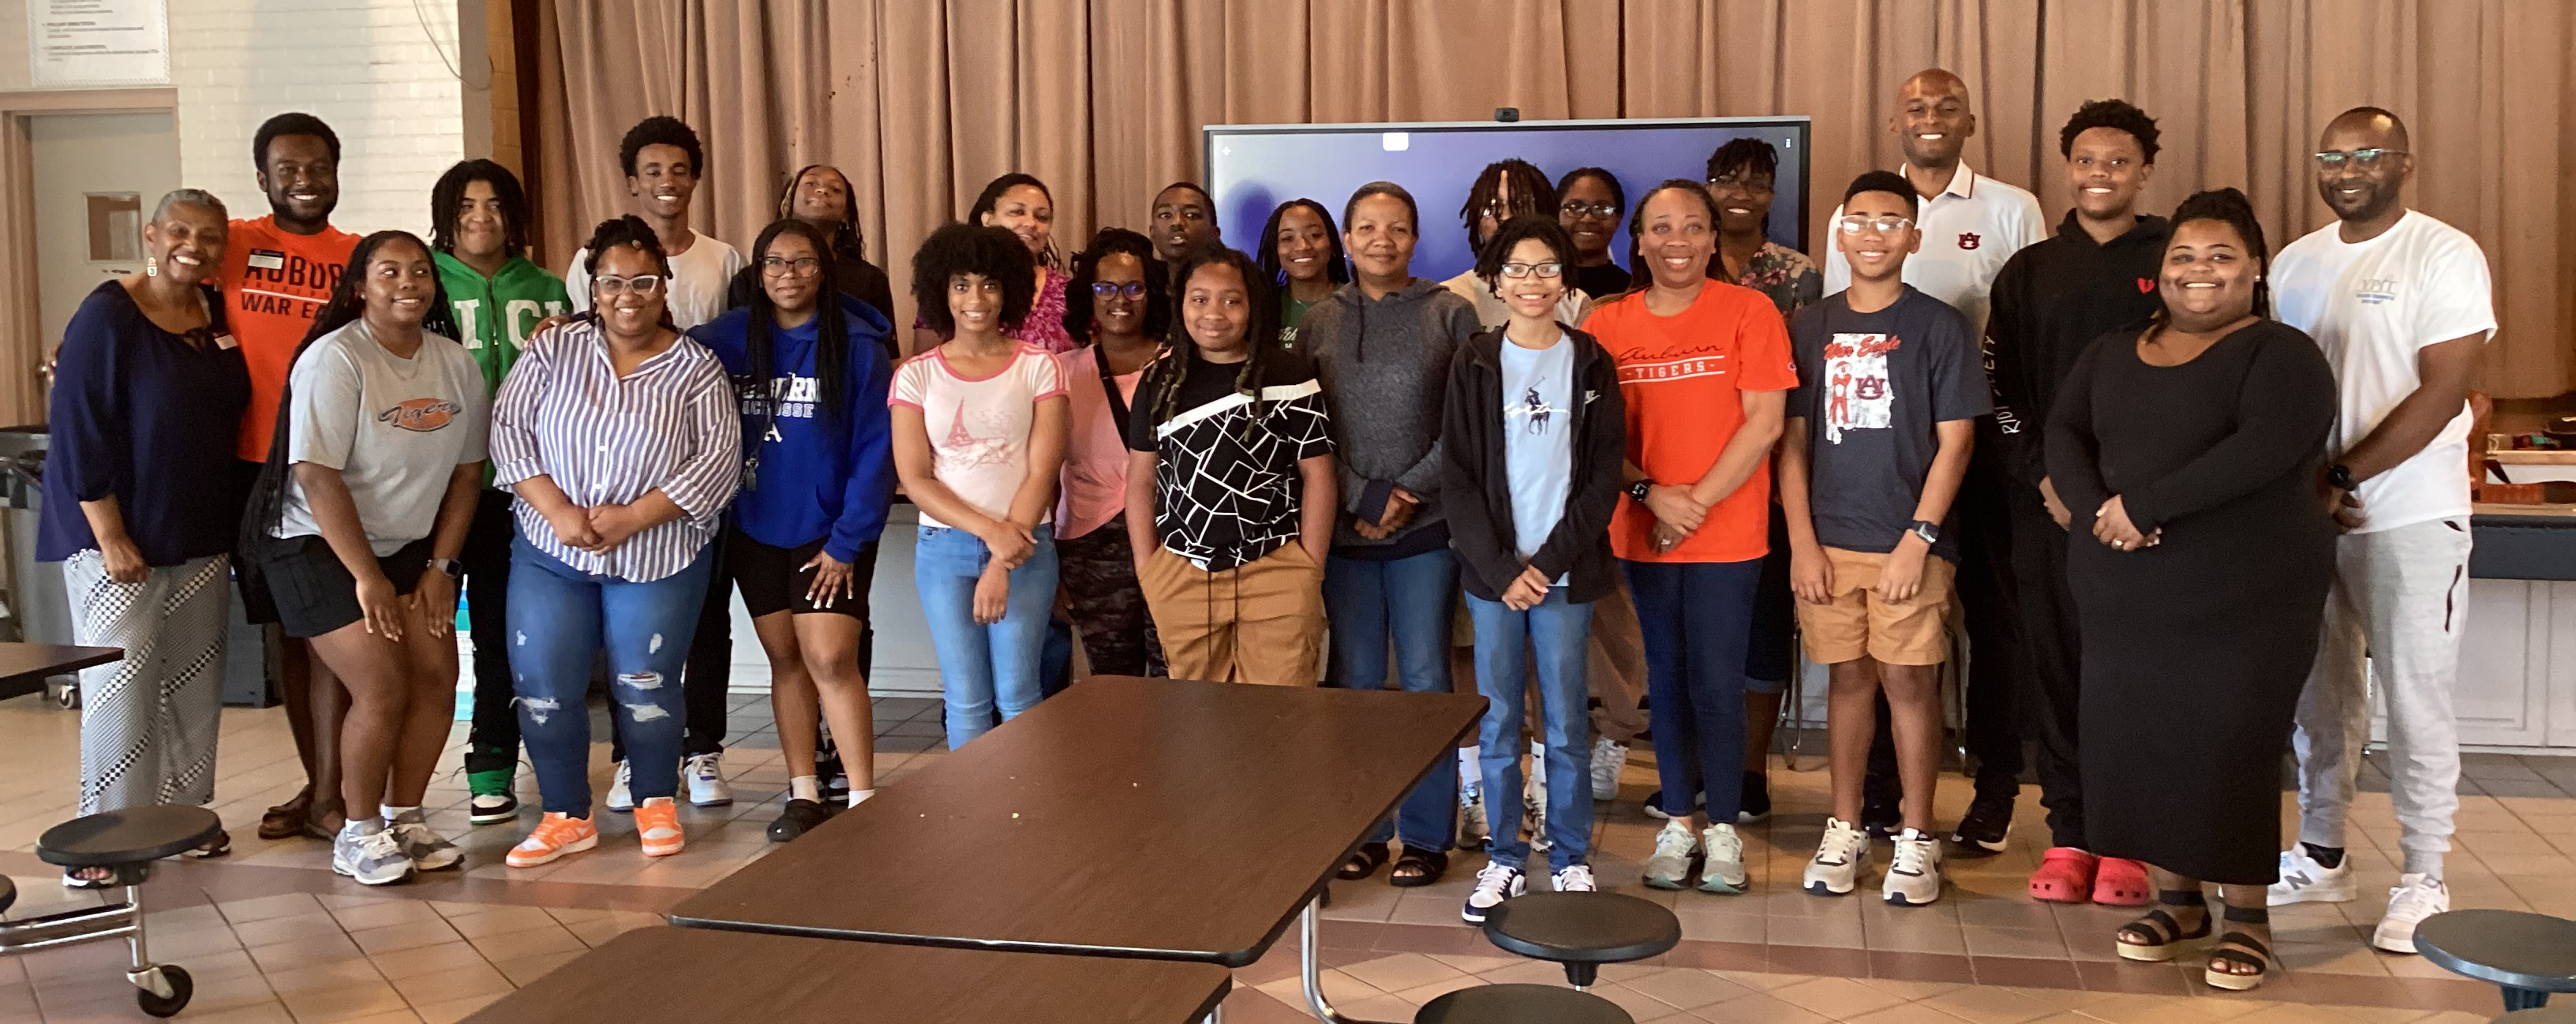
[670,677,1484,1016]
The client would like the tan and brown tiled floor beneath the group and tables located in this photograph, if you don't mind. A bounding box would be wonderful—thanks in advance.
[0,697,2576,1024]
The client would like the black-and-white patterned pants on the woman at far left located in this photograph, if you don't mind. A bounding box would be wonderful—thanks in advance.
[62,548,232,816]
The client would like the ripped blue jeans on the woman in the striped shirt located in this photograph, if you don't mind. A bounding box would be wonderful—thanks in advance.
[510,540,711,818]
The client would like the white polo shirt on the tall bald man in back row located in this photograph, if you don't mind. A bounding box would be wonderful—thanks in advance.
[1816,159,2048,337]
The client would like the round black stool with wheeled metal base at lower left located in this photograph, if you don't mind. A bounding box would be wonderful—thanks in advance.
[0,805,224,1016]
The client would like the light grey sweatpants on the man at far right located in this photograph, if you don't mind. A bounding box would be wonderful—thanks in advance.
[2293,518,2468,877]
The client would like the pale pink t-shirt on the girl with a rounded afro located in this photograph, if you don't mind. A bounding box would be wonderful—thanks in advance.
[886,342,1064,528]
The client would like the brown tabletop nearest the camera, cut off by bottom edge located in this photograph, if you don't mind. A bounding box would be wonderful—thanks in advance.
[466,929,1234,1024]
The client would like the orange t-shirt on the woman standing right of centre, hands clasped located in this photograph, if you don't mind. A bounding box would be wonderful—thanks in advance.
[1584,280,1798,561]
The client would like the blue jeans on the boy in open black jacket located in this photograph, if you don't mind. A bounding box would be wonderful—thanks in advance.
[1466,587,1586,873]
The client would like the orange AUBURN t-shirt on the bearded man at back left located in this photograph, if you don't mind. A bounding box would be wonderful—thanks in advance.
[224,214,358,463]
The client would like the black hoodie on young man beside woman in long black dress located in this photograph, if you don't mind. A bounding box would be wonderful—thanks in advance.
[1975,211,2172,489]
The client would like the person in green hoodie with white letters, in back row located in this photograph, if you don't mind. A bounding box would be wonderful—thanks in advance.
[430,159,572,826]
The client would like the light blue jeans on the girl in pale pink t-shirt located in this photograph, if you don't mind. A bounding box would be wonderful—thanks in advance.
[912,528,1056,751]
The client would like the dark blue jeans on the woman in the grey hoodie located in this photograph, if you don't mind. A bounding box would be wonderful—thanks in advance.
[1324,548,1458,851]
